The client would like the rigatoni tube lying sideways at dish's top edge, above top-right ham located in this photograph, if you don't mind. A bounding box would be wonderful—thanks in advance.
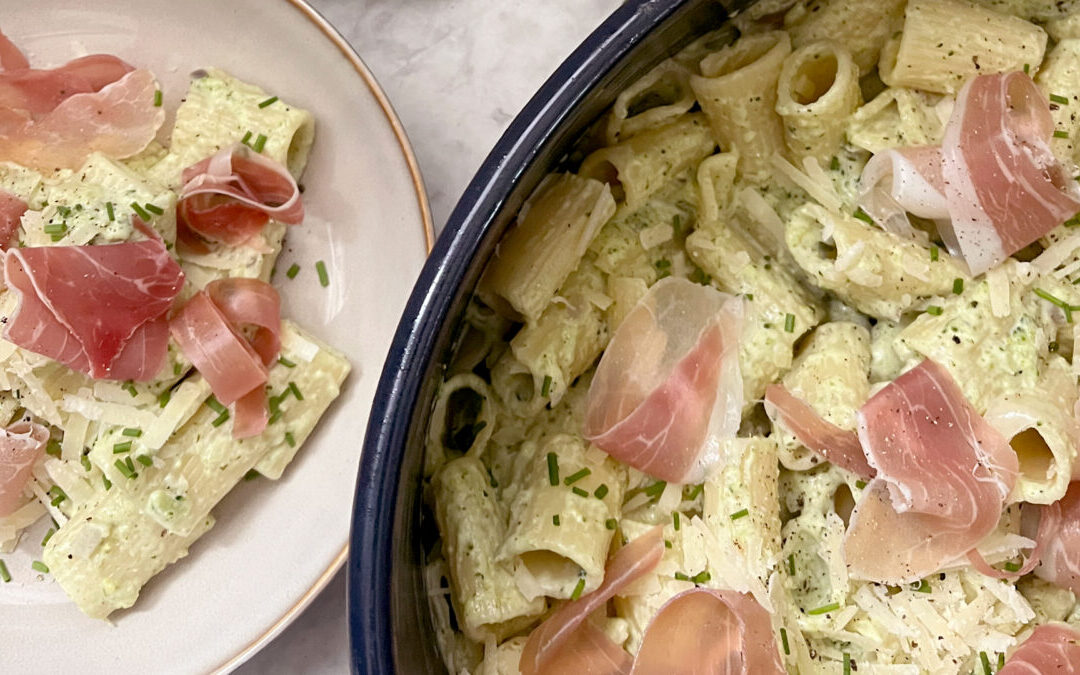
[878,0,1047,94]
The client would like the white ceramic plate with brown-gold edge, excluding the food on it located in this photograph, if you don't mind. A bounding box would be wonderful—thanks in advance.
[0,0,432,673]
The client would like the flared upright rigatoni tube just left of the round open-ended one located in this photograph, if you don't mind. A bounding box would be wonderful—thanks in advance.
[690,31,792,181]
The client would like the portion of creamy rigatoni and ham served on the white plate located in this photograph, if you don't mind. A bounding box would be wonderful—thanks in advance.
[0,36,350,619]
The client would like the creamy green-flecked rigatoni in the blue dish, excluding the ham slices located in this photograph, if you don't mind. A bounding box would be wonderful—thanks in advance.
[424,0,1080,674]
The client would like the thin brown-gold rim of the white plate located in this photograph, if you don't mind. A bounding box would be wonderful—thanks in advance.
[213,0,435,674]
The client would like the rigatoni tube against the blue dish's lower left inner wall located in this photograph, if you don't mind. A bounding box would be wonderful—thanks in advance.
[432,457,544,642]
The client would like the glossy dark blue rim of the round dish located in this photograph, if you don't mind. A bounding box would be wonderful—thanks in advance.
[347,0,686,675]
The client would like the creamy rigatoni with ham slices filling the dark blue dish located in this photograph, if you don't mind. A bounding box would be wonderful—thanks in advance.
[423,0,1080,674]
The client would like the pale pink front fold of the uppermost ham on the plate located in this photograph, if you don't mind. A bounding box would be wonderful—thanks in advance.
[0,69,165,172]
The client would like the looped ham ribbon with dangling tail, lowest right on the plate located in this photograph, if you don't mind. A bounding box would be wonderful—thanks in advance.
[168,279,281,438]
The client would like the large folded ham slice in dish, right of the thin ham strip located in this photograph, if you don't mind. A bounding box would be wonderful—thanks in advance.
[845,360,1018,583]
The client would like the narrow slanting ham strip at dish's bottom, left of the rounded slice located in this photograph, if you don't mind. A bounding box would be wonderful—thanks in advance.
[519,526,664,675]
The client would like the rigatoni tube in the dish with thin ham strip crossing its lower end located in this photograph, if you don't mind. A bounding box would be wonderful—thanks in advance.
[777,321,870,471]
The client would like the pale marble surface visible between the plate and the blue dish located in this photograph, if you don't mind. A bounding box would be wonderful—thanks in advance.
[237,0,620,675]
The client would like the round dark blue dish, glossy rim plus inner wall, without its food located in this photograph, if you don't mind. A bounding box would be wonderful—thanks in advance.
[348,0,750,675]
